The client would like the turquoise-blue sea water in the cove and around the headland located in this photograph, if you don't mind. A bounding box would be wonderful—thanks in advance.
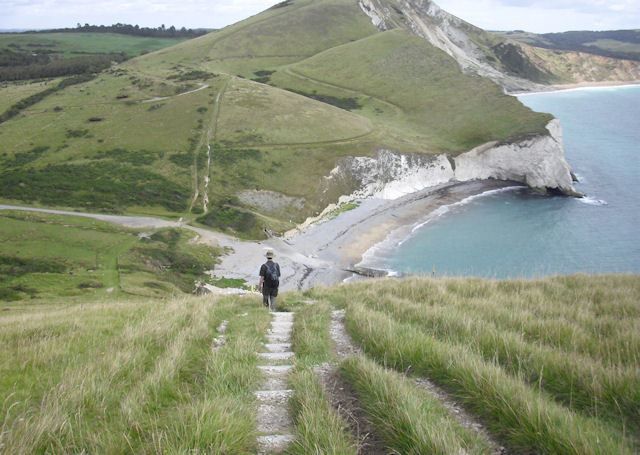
[376,86,640,278]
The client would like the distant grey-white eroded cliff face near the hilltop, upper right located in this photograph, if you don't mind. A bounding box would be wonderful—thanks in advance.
[358,0,640,92]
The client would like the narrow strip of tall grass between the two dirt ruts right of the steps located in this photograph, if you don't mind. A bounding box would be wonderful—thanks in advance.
[341,356,490,455]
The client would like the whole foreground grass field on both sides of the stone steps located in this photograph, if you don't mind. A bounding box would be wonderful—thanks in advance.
[0,276,640,454]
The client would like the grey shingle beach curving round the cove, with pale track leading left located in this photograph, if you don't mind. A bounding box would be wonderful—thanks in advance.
[0,180,524,292]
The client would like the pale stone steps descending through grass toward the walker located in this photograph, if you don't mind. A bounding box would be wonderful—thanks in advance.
[255,312,294,454]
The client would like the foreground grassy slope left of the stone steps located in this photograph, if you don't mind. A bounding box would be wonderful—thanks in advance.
[0,298,269,453]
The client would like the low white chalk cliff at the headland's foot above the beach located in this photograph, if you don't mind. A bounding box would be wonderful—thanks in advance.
[326,120,578,201]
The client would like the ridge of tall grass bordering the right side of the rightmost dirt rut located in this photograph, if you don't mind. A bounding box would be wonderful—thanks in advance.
[347,304,633,455]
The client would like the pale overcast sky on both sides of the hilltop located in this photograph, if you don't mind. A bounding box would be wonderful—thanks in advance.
[0,0,640,33]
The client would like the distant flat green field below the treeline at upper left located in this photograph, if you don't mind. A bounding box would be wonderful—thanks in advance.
[0,33,190,58]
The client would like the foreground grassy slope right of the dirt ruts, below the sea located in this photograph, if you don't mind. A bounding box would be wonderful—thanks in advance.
[317,276,640,453]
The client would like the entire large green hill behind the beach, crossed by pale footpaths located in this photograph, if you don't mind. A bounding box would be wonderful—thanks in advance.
[0,0,550,237]
